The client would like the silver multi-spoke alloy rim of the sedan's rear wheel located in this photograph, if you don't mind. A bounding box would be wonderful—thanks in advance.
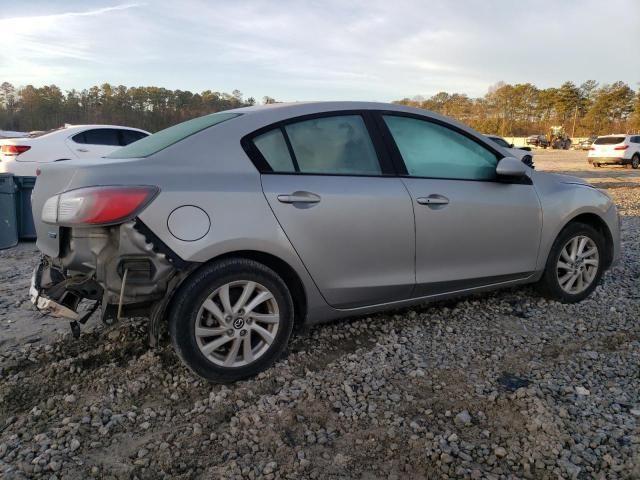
[195,280,280,368]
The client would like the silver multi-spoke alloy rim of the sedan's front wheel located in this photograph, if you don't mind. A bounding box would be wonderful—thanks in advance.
[556,235,600,295]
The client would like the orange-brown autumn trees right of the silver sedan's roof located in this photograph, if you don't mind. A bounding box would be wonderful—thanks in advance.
[395,80,640,137]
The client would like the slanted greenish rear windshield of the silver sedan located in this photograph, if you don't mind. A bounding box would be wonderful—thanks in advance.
[106,113,240,158]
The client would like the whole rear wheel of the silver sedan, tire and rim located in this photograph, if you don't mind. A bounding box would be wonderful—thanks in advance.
[169,258,294,383]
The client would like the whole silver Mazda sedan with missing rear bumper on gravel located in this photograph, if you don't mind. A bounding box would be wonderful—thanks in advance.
[31,102,620,382]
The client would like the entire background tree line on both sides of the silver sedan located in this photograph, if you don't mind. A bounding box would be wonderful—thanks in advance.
[0,80,640,136]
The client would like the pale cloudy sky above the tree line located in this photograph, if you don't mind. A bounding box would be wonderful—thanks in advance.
[0,0,640,101]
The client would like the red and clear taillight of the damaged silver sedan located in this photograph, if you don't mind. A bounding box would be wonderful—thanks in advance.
[42,186,158,226]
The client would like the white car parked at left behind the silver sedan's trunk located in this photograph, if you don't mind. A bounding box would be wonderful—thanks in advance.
[0,125,149,177]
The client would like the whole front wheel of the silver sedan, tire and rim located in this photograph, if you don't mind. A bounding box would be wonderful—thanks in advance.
[540,223,605,303]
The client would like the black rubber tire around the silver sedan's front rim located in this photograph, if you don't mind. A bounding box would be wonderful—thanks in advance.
[538,222,606,303]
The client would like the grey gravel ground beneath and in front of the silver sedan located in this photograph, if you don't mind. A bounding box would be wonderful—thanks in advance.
[0,179,640,479]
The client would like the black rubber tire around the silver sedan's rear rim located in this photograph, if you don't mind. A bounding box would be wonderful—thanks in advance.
[169,258,294,383]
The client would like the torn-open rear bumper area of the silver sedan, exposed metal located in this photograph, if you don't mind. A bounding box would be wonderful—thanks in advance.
[29,221,190,343]
